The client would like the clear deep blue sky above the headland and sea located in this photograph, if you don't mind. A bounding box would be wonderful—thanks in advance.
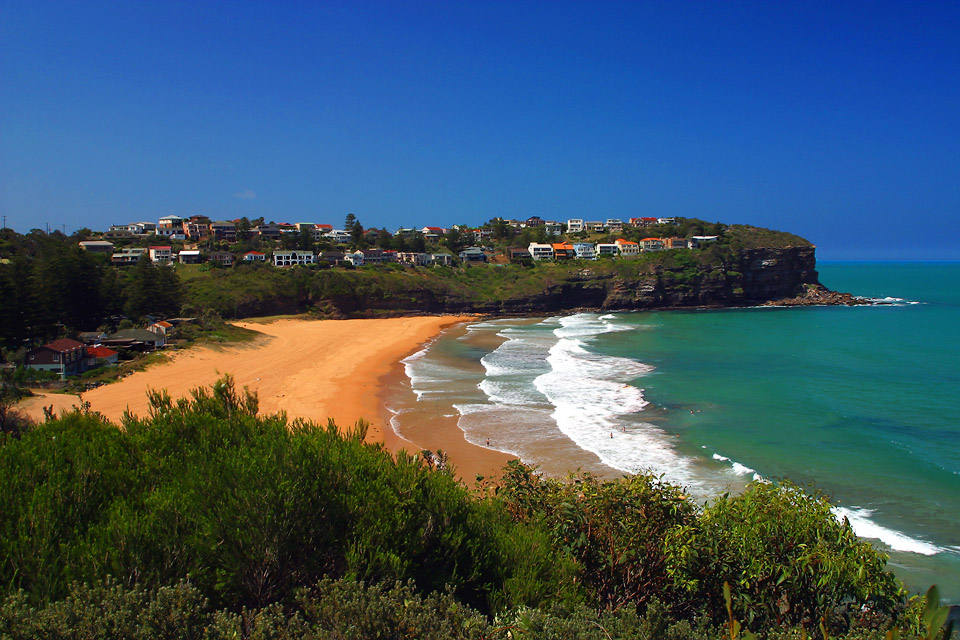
[0,0,960,259]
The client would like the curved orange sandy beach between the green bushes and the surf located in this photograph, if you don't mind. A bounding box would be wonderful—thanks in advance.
[20,316,509,481]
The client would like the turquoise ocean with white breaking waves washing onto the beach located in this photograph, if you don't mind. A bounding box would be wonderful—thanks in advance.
[391,262,960,602]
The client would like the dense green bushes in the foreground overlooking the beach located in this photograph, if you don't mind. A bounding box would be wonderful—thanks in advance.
[0,379,948,640]
